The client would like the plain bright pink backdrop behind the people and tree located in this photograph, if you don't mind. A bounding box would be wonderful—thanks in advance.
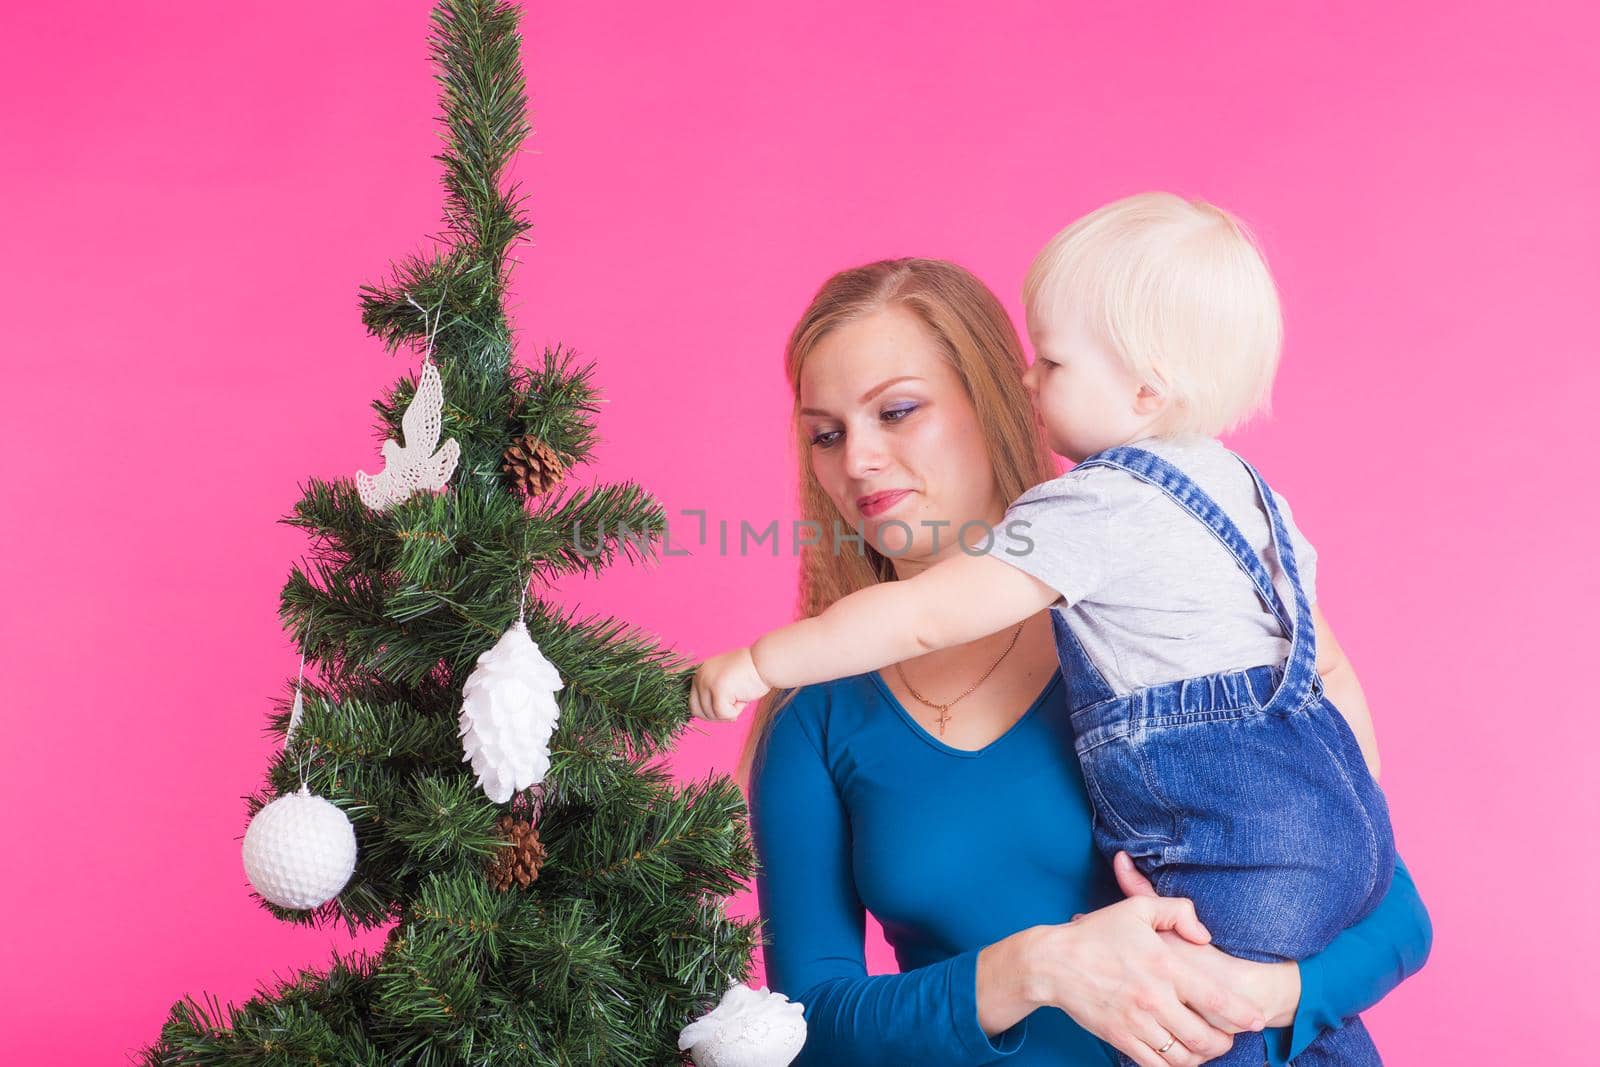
[0,0,1600,1064]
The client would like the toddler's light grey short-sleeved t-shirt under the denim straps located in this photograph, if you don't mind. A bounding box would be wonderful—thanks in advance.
[989,435,1317,696]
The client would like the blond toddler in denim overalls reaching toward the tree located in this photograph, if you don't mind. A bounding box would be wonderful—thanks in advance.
[691,194,1394,1065]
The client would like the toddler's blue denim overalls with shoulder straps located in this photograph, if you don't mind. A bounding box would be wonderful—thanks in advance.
[1050,445,1395,1067]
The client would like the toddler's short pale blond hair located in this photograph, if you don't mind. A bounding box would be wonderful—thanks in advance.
[1022,192,1283,437]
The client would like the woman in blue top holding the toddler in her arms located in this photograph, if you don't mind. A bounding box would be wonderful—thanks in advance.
[741,259,1432,1067]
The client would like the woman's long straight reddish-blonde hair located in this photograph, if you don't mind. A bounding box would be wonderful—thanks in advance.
[738,259,1058,792]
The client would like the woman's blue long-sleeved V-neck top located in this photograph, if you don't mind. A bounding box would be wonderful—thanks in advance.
[750,672,1432,1067]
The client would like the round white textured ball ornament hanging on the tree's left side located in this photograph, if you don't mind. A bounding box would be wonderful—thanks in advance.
[243,785,355,910]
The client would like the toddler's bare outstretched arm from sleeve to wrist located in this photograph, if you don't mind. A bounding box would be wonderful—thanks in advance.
[750,552,1061,689]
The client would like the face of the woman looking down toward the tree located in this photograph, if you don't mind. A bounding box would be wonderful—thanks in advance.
[800,307,1005,574]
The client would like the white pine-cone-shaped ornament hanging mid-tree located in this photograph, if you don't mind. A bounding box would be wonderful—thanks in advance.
[461,619,563,805]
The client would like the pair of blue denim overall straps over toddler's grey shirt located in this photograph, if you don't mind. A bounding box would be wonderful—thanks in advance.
[1074,445,1317,710]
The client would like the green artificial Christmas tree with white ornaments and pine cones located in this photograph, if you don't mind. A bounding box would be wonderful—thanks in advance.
[142,0,757,1067]
